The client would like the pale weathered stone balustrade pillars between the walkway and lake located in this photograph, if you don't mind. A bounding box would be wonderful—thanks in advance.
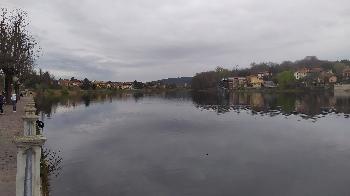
[14,100,46,196]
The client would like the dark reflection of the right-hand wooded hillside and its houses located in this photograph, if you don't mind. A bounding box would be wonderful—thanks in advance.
[192,92,350,118]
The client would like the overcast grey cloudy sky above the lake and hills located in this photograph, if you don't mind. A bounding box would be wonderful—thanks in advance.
[0,0,350,81]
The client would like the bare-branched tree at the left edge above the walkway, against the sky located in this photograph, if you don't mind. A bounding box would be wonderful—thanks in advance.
[0,8,39,101]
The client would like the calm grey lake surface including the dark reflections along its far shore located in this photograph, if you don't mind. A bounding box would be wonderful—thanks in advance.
[39,93,350,196]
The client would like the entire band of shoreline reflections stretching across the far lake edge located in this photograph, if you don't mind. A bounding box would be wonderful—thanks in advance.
[36,91,350,119]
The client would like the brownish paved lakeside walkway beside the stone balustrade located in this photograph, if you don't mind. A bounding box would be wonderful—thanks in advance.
[0,98,28,196]
